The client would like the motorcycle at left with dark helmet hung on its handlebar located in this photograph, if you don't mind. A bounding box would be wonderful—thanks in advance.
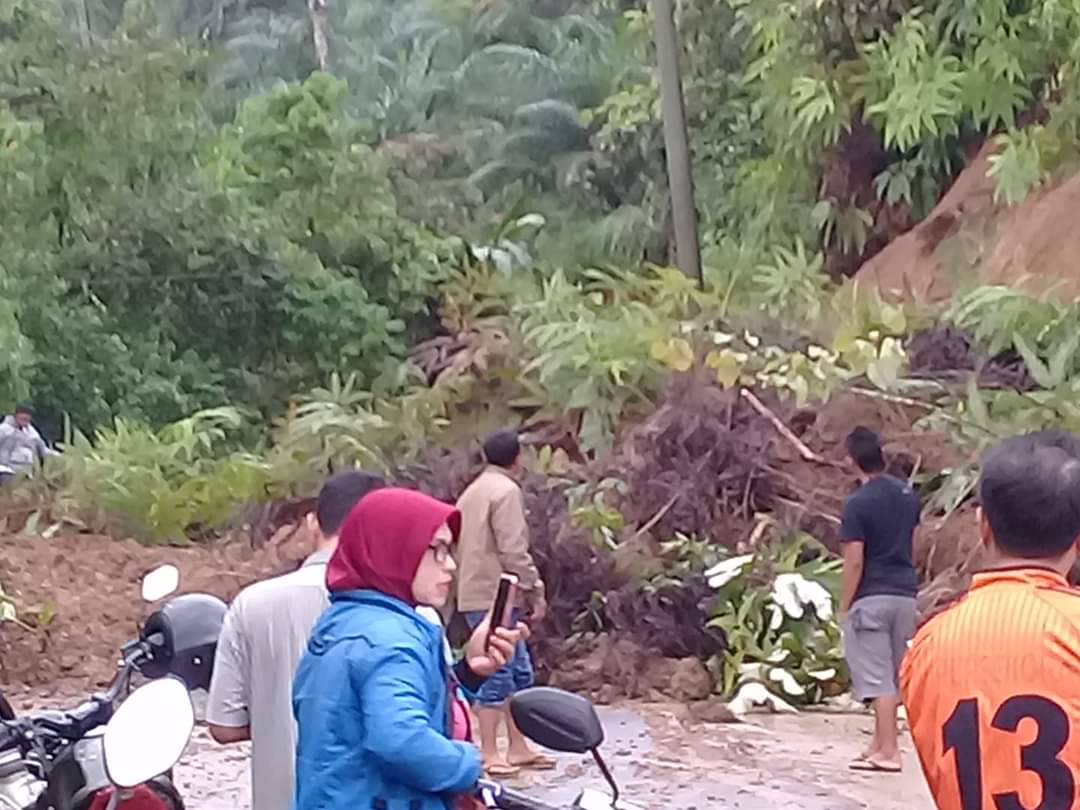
[0,566,227,810]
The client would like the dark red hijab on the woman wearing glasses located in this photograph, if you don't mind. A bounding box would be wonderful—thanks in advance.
[326,487,461,606]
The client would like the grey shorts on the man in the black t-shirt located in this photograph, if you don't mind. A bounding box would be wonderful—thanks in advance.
[840,596,916,701]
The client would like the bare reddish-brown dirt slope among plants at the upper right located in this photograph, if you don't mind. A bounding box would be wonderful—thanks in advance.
[859,144,1080,301]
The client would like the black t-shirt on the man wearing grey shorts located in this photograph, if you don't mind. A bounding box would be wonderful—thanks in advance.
[840,475,921,599]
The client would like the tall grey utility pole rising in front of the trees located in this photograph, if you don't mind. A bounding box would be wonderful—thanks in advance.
[652,0,705,287]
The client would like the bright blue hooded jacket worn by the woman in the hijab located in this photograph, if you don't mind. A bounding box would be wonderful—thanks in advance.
[293,591,481,810]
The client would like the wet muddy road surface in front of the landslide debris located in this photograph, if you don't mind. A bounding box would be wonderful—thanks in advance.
[176,704,933,810]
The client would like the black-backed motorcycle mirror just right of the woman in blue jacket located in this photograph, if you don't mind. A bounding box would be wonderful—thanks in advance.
[510,686,604,754]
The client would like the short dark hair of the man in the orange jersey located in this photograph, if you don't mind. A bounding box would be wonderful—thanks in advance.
[978,430,1080,559]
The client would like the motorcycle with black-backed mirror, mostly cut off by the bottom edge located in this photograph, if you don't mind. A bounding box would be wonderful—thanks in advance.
[476,687,643,810]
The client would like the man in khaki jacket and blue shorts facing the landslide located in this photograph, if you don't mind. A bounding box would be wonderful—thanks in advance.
[457,430,554,777]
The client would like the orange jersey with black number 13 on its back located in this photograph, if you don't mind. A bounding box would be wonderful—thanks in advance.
[901,569,1080,810]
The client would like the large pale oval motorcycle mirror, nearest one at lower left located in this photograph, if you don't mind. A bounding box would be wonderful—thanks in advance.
[103,677,195,787]
